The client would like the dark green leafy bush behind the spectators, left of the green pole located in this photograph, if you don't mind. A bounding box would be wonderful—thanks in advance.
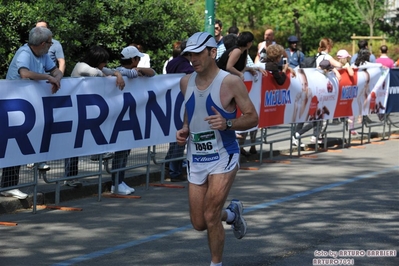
[0,0,203,78]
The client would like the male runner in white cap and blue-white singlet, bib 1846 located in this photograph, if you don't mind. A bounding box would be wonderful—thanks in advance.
[176,32,258,265]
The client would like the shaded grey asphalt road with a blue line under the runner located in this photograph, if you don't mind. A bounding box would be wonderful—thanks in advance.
[0,138,399,266]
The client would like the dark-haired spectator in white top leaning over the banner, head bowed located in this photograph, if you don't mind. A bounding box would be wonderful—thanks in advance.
[64,46,125,187]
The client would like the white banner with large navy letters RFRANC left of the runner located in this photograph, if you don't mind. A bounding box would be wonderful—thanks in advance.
[0,74,184,167]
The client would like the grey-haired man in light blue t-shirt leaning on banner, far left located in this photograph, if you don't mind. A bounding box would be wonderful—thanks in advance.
[1,27,63,199]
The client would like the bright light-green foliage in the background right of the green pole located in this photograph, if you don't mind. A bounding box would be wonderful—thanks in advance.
[216,0,388,54]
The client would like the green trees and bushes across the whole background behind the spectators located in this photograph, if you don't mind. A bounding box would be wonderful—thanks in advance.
[0,0,399,78]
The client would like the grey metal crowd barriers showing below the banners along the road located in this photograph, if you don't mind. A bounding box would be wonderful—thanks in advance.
[0,114,399,213]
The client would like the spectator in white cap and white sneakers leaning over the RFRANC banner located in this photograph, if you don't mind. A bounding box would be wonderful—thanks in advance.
[111,46,155,195]
